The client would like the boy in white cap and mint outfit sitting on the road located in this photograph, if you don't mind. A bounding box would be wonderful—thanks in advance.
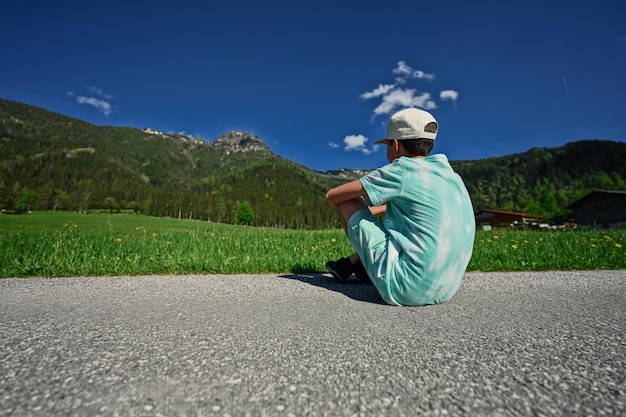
[326,108,475,305]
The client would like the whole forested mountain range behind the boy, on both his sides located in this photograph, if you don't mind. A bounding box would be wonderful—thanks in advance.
[0,99,626,229]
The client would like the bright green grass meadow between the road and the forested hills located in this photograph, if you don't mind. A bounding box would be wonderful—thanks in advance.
[0,212,626,278]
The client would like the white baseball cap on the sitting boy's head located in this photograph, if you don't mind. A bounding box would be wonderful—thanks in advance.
[374,107,439,143]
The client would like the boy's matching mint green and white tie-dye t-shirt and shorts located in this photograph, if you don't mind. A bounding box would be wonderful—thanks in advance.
[349,154,475,305]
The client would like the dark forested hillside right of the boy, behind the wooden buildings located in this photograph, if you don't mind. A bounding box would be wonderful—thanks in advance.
[451,140,626,220]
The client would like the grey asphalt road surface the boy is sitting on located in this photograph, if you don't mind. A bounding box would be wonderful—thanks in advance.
[0,270,626,417]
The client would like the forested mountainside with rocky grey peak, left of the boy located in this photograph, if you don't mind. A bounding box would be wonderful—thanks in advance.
[0,100,345,229]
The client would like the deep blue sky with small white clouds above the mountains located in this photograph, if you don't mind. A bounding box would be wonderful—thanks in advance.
[0,0,626,171]
